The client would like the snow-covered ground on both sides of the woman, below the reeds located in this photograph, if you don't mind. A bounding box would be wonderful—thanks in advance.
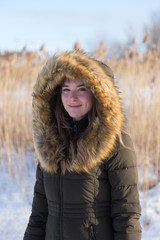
[0,162,160,240]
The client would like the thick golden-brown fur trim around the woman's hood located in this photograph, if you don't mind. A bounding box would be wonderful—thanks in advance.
[33,51,124,173]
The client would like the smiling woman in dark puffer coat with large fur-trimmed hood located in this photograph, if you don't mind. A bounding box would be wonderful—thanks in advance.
[24,49,141,240]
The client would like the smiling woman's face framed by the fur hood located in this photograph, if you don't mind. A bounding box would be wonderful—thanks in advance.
[61,79,93,120]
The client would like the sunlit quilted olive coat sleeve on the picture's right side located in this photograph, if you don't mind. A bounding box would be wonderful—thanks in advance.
[108,134,141,240]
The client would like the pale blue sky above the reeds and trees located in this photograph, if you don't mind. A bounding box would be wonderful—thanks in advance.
[0,0,160,53]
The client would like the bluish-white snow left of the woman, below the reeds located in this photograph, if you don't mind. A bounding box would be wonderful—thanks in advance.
[0,154,36,240]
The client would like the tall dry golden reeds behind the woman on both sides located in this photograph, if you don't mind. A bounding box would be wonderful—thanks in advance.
[0,39,160,193]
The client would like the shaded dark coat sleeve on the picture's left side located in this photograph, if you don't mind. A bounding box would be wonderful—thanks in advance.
[23,165,48,240]
